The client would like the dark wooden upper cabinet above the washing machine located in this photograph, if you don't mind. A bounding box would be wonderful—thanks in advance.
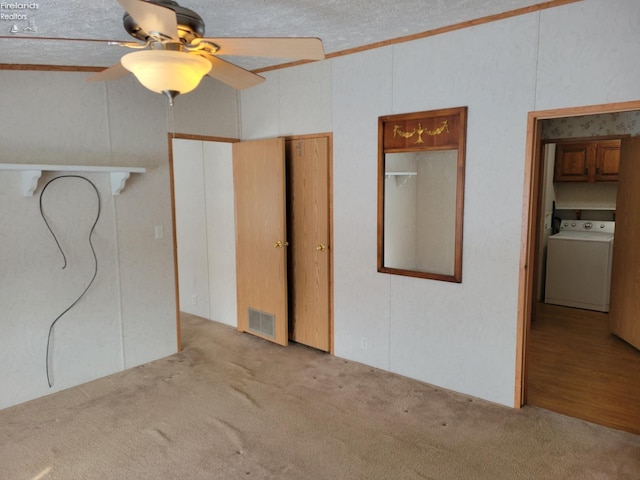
[554,140,620,182]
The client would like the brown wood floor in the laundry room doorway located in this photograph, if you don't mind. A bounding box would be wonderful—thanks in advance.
[526,303,640,434]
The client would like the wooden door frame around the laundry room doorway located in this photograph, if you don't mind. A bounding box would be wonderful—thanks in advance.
[514,100,640,408]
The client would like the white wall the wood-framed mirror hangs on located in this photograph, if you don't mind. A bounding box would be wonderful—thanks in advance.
[241,0,640,405]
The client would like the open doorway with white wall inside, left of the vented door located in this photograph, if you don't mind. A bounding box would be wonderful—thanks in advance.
[168,133,238,348]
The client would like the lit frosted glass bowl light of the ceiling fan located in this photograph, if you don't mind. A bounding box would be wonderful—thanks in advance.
[121,50,211,95]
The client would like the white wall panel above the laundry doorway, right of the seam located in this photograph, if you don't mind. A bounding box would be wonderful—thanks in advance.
[535,0,640,110]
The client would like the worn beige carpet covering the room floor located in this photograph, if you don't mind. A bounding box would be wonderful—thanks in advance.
[0,316,640,480]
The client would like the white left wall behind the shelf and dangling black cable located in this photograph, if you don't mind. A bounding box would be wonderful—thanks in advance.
[0,71,237,408]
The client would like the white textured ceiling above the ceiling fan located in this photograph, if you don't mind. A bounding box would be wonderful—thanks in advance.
[0,0,547,69]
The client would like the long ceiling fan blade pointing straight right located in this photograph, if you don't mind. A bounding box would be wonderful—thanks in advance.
[193,37,324,60]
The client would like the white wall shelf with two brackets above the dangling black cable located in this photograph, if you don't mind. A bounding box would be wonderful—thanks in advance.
[0,163,147,197]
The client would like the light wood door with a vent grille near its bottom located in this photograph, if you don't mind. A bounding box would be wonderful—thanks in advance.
[233,138,289,345]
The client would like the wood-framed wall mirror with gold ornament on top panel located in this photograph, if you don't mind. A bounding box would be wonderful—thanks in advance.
[378,107,467,283]
